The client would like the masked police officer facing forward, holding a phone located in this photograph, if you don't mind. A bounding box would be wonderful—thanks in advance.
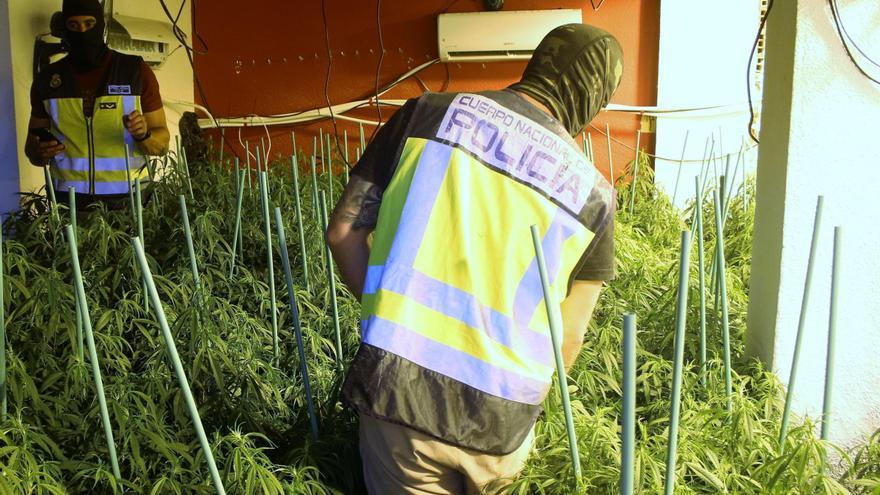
[25,0,170,208]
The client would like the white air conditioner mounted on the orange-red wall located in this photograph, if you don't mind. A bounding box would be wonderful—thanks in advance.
[437,9,583,62]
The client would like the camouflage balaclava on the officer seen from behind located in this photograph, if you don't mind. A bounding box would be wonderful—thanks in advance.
[510,24,623,136]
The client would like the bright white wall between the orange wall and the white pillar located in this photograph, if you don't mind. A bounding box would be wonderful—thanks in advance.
[655,0,760,206]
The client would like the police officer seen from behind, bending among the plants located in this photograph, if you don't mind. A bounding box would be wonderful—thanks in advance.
[327,24,623,494]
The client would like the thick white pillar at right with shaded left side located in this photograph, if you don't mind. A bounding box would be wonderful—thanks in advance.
[747,0,880,452]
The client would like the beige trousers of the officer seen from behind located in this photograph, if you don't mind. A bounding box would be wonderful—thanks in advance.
[360,414,535,495]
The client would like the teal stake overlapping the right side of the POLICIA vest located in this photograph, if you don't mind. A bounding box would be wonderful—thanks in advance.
[531,225,581,482]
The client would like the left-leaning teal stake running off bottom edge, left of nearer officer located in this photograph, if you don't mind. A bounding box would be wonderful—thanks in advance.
[131,237,226,495]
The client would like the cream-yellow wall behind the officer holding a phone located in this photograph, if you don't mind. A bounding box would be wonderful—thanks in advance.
[7,0,193,198]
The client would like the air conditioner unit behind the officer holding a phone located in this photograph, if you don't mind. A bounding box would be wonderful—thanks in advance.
[107,14,178,67]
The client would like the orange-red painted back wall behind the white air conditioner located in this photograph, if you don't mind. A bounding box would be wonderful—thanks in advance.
[194,0,660,182]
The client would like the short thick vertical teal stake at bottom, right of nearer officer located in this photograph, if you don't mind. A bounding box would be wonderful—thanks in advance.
[620,313,636,495]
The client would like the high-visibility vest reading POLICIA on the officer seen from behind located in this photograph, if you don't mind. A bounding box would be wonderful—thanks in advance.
[350,93,613,453]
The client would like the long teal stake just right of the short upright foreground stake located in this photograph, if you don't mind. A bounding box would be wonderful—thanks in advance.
[664,230,691,495]
